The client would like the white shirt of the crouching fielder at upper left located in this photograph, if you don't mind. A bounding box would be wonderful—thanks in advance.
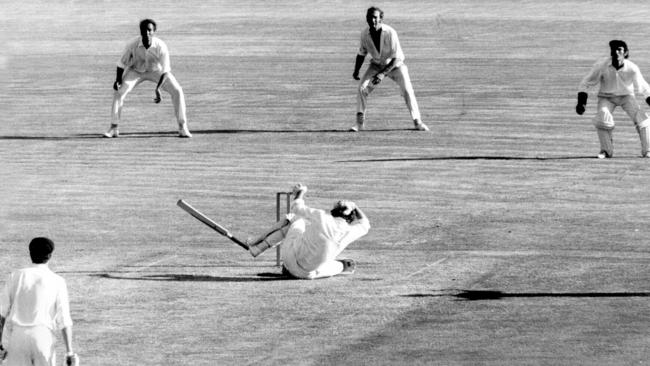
[117,36,171,74]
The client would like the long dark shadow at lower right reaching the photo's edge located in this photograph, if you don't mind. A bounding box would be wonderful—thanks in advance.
[404,290,650,301]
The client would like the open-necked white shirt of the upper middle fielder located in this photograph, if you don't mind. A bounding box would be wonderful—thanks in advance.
[359,24,404,67]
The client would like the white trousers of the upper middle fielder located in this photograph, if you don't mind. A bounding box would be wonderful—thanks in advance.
[357,63,420,119]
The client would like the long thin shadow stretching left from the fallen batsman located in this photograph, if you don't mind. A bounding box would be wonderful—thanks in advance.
[93,273,294,282]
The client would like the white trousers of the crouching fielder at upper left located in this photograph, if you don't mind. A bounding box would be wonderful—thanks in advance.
[111,69,187,125]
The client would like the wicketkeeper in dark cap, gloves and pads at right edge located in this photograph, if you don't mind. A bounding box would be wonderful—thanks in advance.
[576,39,650,159]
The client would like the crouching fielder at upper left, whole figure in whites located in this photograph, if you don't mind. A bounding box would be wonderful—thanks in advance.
[104,19,192,138]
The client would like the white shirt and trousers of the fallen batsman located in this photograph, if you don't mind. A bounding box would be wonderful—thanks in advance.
[282,199,370,279]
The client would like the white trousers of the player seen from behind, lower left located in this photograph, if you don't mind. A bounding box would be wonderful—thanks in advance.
[3,324,56,366]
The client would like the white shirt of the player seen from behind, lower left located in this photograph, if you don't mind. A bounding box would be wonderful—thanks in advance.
[0,264,72,331]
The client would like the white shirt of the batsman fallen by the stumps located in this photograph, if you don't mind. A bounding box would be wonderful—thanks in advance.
[291,199,370,272]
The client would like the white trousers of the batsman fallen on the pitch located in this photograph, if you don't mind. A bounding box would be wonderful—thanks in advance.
[282,219,343,280]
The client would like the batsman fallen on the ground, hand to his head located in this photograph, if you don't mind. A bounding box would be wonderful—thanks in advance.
[247,184,370,279]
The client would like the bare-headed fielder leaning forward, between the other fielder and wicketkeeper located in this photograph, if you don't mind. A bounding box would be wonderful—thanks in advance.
[350,7,429,132]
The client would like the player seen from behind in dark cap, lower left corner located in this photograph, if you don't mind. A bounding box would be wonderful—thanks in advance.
[0,237,79,366]
